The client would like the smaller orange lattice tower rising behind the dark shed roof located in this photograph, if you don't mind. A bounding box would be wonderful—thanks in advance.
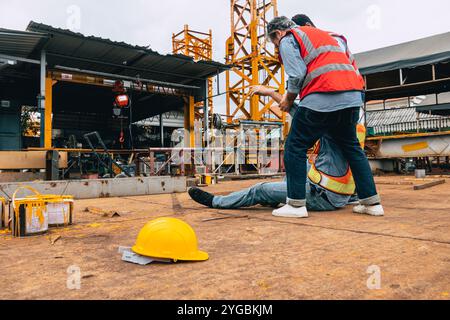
[172,25,214,117]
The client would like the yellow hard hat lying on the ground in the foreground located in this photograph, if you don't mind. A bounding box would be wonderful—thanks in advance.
[132,218,209,261]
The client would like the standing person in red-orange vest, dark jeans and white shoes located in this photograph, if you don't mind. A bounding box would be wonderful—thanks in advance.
[267,15,384,218]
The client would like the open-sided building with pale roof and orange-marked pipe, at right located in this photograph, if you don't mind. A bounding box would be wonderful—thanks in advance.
[356,33,450,171]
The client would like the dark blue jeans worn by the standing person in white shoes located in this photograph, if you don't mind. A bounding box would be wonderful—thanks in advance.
[284,107,381,206]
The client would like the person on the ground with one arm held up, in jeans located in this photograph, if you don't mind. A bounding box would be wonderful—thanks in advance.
[189,86,366,211]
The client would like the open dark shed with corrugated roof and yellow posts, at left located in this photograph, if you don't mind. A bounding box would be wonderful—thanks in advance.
[0,22,228,180]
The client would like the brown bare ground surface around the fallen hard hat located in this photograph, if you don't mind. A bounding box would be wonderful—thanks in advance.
[0,177,450,300]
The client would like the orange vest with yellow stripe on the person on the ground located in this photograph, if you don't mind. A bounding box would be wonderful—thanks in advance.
[308,124,366,196]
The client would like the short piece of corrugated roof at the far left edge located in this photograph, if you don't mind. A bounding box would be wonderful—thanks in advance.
[0,28,48,58]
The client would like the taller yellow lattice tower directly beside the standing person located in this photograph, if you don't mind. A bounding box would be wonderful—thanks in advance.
[226,0,287,133]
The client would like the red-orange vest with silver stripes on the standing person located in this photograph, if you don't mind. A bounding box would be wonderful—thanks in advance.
[288,27,365,100]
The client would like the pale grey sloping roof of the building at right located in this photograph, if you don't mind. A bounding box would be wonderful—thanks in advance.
[355,32,450,75]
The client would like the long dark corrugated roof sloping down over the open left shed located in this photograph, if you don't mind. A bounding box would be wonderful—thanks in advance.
[27,21,228,85]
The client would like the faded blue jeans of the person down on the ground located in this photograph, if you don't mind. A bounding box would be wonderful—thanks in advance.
[213,182,337,211]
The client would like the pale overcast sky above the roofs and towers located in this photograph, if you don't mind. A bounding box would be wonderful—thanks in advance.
[0,0,450,114]
